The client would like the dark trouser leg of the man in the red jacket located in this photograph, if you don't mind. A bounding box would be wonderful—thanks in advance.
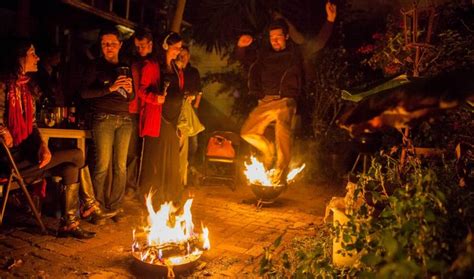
[126,114,142,191]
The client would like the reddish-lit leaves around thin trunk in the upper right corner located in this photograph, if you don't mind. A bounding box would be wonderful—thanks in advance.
[358,1,474,76]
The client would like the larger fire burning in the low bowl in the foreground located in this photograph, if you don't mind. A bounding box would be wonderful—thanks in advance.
[132,194,211,267]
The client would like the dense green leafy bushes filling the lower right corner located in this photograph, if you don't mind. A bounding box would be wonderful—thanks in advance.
[260,156,474,278]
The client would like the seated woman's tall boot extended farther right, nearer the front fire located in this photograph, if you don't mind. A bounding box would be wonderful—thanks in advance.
[79,166,117,224]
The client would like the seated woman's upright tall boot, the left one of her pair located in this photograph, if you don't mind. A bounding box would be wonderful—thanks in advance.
[58,183,95,239]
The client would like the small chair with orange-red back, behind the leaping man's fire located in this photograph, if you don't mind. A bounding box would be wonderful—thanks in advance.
[200,131,240,190]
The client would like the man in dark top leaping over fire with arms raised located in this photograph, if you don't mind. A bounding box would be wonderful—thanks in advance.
[236,2,336,185]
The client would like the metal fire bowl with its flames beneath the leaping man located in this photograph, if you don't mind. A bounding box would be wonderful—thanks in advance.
[244,156,305,208]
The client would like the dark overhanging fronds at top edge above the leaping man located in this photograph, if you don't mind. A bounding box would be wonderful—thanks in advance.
[188,0,325,54]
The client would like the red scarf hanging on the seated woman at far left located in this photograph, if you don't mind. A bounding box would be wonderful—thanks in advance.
[8,76,34,146]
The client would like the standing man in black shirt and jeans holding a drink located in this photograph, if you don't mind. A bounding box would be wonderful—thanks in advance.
[81,29,134,215]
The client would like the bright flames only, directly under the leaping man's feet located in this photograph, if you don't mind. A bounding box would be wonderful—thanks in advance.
[244,156,306,186]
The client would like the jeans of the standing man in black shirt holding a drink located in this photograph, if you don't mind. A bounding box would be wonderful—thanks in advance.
[92,113,132,209]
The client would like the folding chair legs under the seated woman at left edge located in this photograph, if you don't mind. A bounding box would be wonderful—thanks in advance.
[0,138,46,233]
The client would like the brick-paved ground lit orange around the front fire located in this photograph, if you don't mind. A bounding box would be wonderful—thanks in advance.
[0,179,340,278]
